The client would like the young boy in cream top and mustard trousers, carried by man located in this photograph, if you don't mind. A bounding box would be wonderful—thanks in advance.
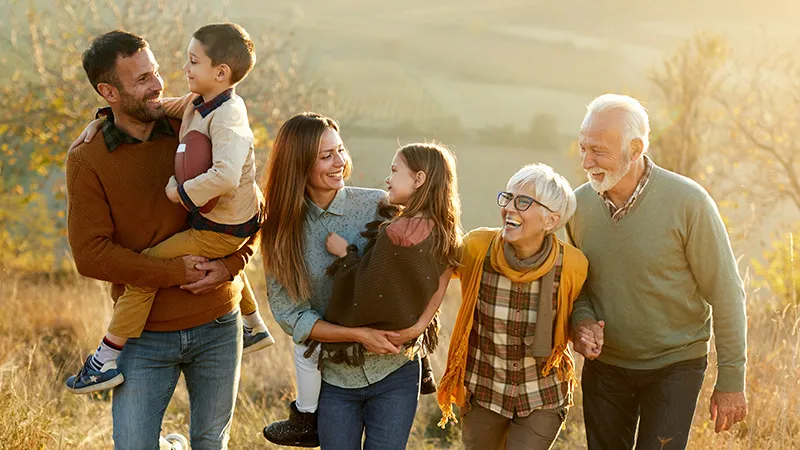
[66,23,275,394]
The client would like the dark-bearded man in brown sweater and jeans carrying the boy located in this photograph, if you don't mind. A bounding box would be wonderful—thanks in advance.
[66,31,256,450]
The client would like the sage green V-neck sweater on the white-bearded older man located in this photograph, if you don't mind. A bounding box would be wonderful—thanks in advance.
[567,163,747,392]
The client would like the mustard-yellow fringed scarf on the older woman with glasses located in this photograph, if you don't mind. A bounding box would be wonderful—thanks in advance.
[437,228,589,428]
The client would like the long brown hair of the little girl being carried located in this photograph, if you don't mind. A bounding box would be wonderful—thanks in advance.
[395,143,463,267]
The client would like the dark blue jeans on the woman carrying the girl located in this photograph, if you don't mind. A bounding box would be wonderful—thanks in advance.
[317,358,420,450]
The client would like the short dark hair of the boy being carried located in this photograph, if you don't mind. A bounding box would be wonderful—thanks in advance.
[194,23,256,84]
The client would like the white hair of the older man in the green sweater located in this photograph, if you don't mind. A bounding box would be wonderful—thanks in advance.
[581,94,650,152]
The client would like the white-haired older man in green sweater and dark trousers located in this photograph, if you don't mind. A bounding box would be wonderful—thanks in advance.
[567,94,747,450]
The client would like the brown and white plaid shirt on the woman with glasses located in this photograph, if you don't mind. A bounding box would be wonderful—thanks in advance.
[465,246,571,418]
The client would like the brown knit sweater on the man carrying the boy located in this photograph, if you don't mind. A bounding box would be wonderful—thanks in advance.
[66,120,257,331]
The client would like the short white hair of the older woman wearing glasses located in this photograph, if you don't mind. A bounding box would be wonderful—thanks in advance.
[508,163,577,232]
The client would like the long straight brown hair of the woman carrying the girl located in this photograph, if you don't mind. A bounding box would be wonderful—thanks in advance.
[261,112,353,300]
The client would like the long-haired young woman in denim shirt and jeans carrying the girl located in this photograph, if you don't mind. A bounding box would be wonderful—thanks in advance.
[262,113,449,449]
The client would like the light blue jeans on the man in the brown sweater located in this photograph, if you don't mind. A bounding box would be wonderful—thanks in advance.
[112,310,242,450]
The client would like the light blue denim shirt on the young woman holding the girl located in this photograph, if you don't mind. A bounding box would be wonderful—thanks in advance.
[267,187,416,389]
